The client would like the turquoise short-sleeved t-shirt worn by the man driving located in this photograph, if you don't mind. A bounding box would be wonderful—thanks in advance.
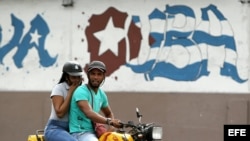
[69,85,108,133]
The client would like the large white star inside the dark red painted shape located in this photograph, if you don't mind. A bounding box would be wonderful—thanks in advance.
[94,18,124,56]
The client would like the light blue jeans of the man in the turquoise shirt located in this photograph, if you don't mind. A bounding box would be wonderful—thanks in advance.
[72,132,98,141]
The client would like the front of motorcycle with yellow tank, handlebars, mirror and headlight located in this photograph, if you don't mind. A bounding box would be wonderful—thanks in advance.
[99,108,163,141]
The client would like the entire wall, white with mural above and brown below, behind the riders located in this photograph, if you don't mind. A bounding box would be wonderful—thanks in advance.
[0,0,250,141]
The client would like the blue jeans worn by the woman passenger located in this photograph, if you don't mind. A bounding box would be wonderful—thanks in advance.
[44,120,77,141]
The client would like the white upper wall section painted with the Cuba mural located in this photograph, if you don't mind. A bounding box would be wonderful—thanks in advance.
[0,1,248,92]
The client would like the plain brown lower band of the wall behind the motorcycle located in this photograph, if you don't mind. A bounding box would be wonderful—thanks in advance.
[0,91,250,141]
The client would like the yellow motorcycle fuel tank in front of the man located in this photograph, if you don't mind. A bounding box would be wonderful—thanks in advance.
[99,132,134,141]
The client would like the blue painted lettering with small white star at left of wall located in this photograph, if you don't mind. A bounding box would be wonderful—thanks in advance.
[0,14,57,68]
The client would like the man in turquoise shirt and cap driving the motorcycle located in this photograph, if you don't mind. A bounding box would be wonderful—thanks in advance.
[69,61,120,141]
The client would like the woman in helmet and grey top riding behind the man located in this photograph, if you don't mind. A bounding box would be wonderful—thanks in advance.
[44,61,82,141]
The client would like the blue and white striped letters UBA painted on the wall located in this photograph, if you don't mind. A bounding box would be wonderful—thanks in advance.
[128,5,246,83]
